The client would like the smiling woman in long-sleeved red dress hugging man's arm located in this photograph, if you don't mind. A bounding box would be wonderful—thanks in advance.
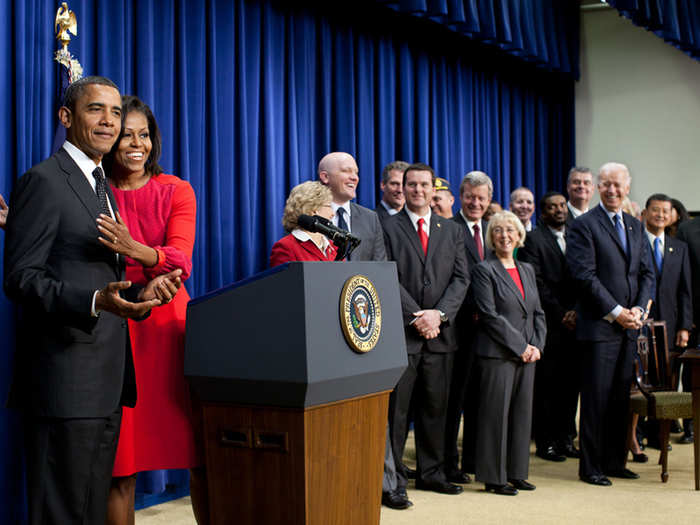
[98,96,207,524]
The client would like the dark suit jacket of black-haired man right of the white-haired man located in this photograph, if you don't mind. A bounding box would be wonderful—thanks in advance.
[646,235,693,340]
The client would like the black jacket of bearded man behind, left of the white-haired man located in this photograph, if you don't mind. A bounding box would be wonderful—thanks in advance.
[518,224,576,333]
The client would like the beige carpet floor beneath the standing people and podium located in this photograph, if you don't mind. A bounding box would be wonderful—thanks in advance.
[136,439,700,525]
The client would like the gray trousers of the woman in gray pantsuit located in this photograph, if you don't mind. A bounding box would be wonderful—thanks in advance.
[476,357,535,485]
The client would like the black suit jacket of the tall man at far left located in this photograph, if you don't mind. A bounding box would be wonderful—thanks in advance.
[4,149,136,418]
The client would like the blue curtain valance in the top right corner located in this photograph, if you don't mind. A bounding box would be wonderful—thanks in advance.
[608,0,700,60]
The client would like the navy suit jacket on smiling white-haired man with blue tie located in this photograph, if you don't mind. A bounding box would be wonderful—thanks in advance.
[566,206,654,341]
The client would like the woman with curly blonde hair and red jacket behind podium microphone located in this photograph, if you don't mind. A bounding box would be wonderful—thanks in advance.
[270,181,338,266]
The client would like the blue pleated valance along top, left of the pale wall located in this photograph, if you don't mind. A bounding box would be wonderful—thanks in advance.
[374,0,580,78]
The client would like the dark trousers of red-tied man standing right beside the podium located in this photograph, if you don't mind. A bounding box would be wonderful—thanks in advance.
[389,352,454,489]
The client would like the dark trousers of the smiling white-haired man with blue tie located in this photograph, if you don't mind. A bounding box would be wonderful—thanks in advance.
[579,336,635,476]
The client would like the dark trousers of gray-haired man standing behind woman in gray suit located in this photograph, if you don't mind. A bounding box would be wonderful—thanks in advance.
[445,348,479,472]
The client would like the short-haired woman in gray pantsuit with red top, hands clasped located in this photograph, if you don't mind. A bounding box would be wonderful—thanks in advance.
[471,211,546,496]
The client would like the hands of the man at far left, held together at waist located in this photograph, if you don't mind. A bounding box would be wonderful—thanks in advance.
[95,269,182,319]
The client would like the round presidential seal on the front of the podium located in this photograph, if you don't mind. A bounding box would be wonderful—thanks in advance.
[340,275,382,353]
